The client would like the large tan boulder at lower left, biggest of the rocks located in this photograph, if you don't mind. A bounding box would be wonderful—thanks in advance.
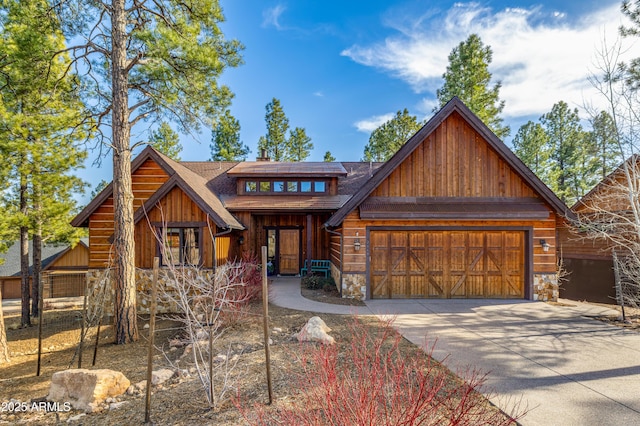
[47,369,130,413]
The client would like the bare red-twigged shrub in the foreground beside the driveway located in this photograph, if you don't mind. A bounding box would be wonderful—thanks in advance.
[241,319,523,426]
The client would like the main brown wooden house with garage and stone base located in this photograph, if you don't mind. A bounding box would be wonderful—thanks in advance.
[72,98,571,299]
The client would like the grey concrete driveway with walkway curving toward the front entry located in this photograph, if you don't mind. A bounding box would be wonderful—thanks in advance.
[270,279,640,426]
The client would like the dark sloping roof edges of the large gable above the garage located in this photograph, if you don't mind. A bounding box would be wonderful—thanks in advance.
[323,97,574,227]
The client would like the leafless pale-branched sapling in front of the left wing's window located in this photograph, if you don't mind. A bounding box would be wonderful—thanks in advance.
[149,218,261,409]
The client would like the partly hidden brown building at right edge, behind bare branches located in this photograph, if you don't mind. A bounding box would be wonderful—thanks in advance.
[558,155,640,303]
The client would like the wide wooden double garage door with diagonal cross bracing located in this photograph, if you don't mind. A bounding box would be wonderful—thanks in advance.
[369,231,525,299]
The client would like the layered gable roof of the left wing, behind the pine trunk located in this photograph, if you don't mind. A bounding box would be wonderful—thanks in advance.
[71,146,244,229]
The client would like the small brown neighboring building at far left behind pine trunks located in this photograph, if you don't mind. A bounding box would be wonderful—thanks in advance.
[0,238,89,299]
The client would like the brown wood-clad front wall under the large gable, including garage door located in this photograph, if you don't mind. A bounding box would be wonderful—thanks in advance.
[332,111,557,298]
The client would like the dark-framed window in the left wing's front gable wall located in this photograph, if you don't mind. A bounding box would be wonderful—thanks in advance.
[161,228,201,265]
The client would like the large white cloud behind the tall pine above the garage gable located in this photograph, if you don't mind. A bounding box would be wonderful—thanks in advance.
[342,1,640,117]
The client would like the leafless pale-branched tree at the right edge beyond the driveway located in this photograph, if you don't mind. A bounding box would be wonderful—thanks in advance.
[572,37,640,306]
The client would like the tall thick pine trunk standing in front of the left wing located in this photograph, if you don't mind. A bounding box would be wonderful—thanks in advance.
[111,0,138,344]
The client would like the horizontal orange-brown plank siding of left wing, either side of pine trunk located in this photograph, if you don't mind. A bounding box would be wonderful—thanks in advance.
[89,159,169,268]
